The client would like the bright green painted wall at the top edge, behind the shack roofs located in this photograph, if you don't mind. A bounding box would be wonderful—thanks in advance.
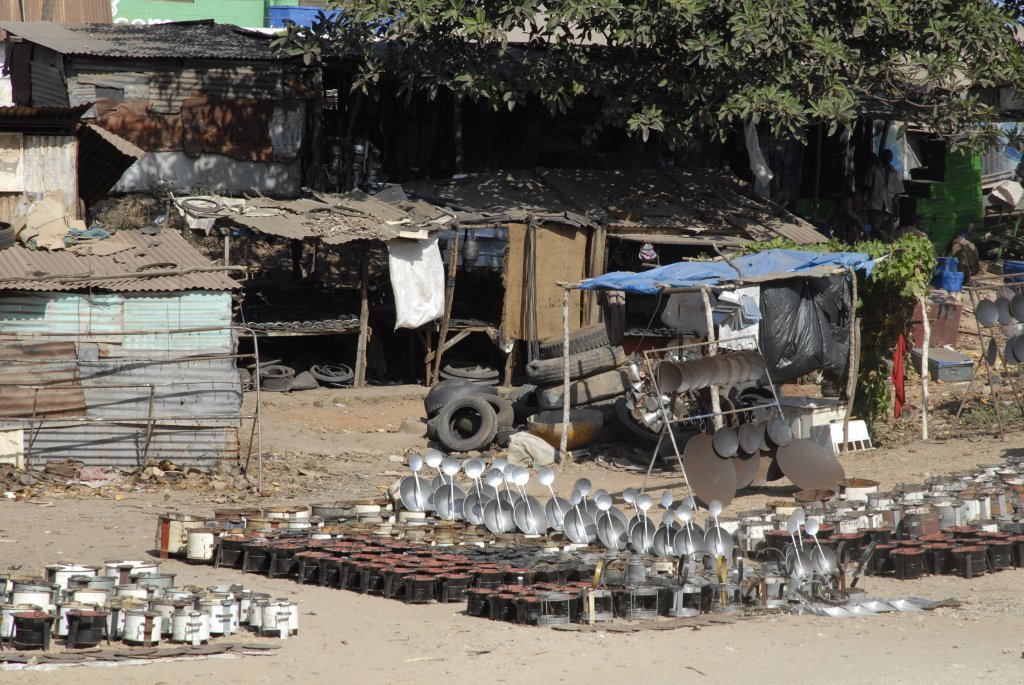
[111,0,270,29]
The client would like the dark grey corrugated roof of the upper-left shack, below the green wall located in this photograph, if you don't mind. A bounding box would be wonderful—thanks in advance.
[0,22,286,60]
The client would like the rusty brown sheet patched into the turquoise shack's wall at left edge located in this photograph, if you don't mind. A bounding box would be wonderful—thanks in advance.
[0,341,85,420]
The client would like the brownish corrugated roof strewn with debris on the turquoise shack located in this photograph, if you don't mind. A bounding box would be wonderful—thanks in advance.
[0,230,239,293]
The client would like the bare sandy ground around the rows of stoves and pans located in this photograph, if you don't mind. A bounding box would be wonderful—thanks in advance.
[0,387,1024,685]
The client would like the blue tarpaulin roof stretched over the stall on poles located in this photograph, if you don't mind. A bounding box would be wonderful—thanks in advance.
[580,250,874,295]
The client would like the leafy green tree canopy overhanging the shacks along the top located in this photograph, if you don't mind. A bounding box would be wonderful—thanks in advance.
[275,0,1024,145]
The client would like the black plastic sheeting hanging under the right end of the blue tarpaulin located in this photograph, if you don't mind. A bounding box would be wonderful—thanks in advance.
[761,275,851,383]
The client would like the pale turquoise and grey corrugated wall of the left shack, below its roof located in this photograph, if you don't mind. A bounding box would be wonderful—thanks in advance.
[0,291,242,467]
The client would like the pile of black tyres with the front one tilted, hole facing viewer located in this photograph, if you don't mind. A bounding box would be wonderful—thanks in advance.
[423,378,515,453]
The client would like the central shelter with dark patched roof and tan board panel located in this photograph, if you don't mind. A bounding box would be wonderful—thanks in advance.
[401,169,823,379]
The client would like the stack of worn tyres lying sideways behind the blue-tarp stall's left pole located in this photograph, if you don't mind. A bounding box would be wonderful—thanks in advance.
[526,325,630,410]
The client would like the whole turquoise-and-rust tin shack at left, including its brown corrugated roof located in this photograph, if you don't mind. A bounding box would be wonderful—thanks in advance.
[0,230,242,468]
